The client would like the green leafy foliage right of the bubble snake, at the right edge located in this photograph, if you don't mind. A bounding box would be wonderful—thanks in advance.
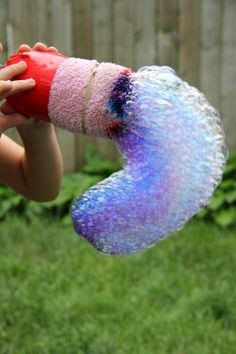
[198,152,236,228]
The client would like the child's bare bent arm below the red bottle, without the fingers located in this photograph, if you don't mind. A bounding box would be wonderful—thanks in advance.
[0,121,62,201]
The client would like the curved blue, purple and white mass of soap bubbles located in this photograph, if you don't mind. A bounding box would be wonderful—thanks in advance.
[72,66,227,254]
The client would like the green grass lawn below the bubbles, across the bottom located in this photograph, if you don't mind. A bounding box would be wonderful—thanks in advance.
[0,219,236,354]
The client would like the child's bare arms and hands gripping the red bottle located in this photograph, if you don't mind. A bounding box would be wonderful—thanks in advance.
[0,44,63,201]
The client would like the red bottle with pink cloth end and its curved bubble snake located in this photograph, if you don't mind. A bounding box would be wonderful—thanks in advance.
[4,51,227,254]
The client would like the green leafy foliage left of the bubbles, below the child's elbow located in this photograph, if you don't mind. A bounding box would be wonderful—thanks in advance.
[0,145,121,223]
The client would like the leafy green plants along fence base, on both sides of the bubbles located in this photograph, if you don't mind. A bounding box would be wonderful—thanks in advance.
[0,145,236,228]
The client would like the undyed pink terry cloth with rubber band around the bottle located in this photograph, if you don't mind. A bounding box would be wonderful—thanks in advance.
[48,58,124,136]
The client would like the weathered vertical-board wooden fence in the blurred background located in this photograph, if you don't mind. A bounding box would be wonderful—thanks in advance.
[0,0,236,171]
